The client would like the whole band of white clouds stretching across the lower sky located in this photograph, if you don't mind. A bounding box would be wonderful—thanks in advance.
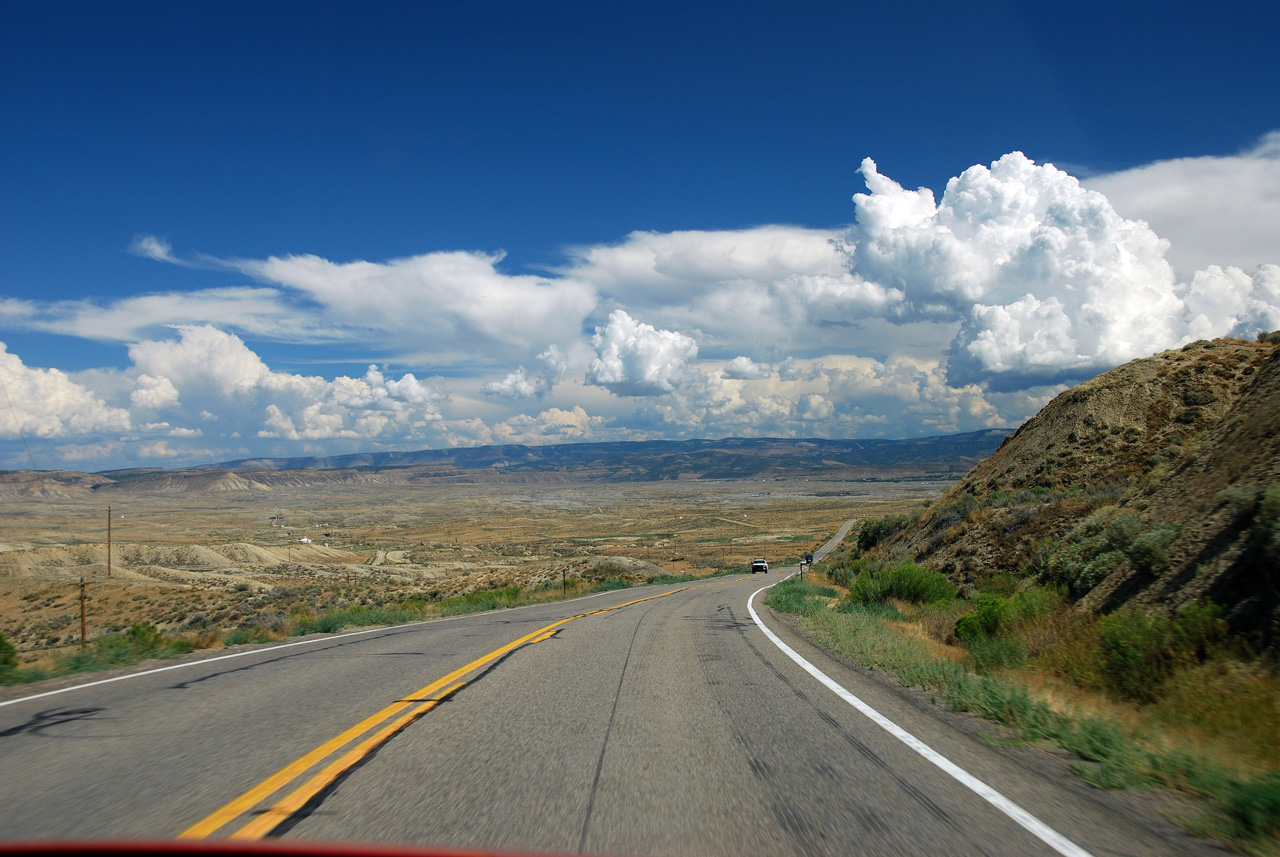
[0,134,1280,467]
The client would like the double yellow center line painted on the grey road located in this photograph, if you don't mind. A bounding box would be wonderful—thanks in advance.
[178,578,745,839]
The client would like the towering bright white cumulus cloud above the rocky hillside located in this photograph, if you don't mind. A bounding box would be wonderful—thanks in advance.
[847,152,1276,389]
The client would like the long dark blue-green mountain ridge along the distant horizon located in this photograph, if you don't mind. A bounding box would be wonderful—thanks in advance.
[0,429,1012,498]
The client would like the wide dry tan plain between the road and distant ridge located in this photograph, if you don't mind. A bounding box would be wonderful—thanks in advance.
[0,480,947,666]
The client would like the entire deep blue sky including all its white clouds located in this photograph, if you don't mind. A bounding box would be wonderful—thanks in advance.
[0,3,1280,469]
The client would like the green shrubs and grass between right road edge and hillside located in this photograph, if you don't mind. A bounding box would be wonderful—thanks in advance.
[767,526,1280,854]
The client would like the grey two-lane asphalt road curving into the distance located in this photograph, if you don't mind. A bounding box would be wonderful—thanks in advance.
[0,526,1221,854]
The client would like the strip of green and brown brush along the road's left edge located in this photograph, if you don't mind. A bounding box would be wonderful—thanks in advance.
[0,570,726,684]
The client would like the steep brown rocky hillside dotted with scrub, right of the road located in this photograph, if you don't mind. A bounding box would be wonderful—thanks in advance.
[876,334,1280,646]
